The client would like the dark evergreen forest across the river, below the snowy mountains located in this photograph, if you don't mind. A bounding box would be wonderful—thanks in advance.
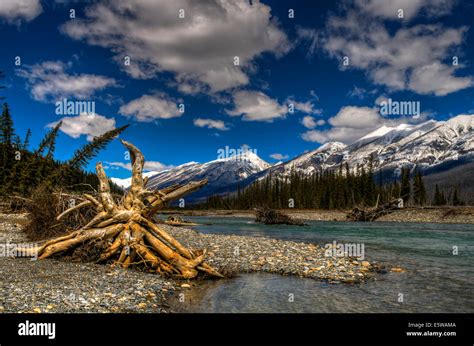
[197,158,463,209]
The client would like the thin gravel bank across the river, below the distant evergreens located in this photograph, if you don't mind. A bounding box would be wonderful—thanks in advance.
[168,206,474,224]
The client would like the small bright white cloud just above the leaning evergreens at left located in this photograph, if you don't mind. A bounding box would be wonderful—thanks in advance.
[46,113,115,141]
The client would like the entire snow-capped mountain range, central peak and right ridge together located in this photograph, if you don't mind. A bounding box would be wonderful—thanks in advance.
[113,115,474,201]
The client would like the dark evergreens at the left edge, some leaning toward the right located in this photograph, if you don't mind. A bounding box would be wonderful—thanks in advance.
[0,103,128,196]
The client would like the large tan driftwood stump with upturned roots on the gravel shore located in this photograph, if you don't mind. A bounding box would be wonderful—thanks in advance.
[18,141,223,279]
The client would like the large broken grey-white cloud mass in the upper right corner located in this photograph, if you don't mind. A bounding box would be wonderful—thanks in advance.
[298,0,474,96]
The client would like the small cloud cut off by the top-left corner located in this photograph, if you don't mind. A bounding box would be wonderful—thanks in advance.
[0,0,43,24]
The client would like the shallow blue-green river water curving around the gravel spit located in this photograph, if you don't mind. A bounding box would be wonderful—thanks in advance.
[175,217,474,312]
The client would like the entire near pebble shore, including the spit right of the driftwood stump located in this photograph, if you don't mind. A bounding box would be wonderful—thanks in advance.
[0,214,383,313]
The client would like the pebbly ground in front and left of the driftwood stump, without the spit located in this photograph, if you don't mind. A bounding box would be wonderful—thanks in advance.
[0,214,183,313]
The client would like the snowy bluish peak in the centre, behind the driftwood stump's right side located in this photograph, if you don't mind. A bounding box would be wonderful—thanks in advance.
[147,151,271,200]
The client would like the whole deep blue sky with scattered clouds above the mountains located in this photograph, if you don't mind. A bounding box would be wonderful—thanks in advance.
[0,0,474,177]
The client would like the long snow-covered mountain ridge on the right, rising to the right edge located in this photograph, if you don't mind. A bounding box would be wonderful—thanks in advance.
[256,115,474,179]
